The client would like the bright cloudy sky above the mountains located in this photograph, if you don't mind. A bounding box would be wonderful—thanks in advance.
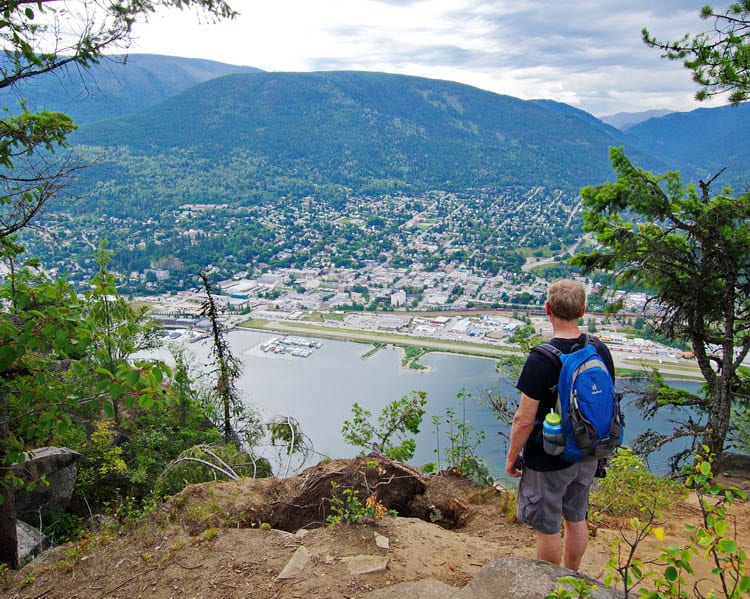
[129,0,725,116]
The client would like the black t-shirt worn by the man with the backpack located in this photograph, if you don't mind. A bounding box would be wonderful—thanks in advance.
[516,333,615,472]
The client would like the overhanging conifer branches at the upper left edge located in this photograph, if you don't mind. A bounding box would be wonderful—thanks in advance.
[0,0,235,237]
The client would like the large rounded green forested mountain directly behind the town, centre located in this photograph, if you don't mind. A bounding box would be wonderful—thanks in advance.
[67,72,660,202]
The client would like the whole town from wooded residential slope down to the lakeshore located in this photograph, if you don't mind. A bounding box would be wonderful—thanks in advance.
[19,187,704,376]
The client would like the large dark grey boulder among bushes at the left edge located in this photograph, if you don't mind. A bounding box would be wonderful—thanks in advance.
[16,447,81,522]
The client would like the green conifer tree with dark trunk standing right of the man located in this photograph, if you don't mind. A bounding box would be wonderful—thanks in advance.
[573,148,750,464]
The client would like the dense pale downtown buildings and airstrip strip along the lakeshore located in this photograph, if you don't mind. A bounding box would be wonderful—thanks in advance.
[141,265,697,376]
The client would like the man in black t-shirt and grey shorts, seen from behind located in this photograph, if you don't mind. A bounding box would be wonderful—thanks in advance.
[505,280,614,571]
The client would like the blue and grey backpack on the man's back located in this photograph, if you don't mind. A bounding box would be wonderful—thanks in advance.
[533,335,625,462]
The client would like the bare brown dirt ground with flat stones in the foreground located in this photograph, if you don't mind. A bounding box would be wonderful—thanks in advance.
[0,458,750,599]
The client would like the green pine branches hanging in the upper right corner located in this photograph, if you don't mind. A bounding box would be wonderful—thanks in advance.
[642,0,750,104]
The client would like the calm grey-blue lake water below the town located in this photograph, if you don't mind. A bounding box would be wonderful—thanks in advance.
[159,330,695,479]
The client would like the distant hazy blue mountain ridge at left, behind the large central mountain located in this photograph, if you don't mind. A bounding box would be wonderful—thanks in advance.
[0,54,259,124]
